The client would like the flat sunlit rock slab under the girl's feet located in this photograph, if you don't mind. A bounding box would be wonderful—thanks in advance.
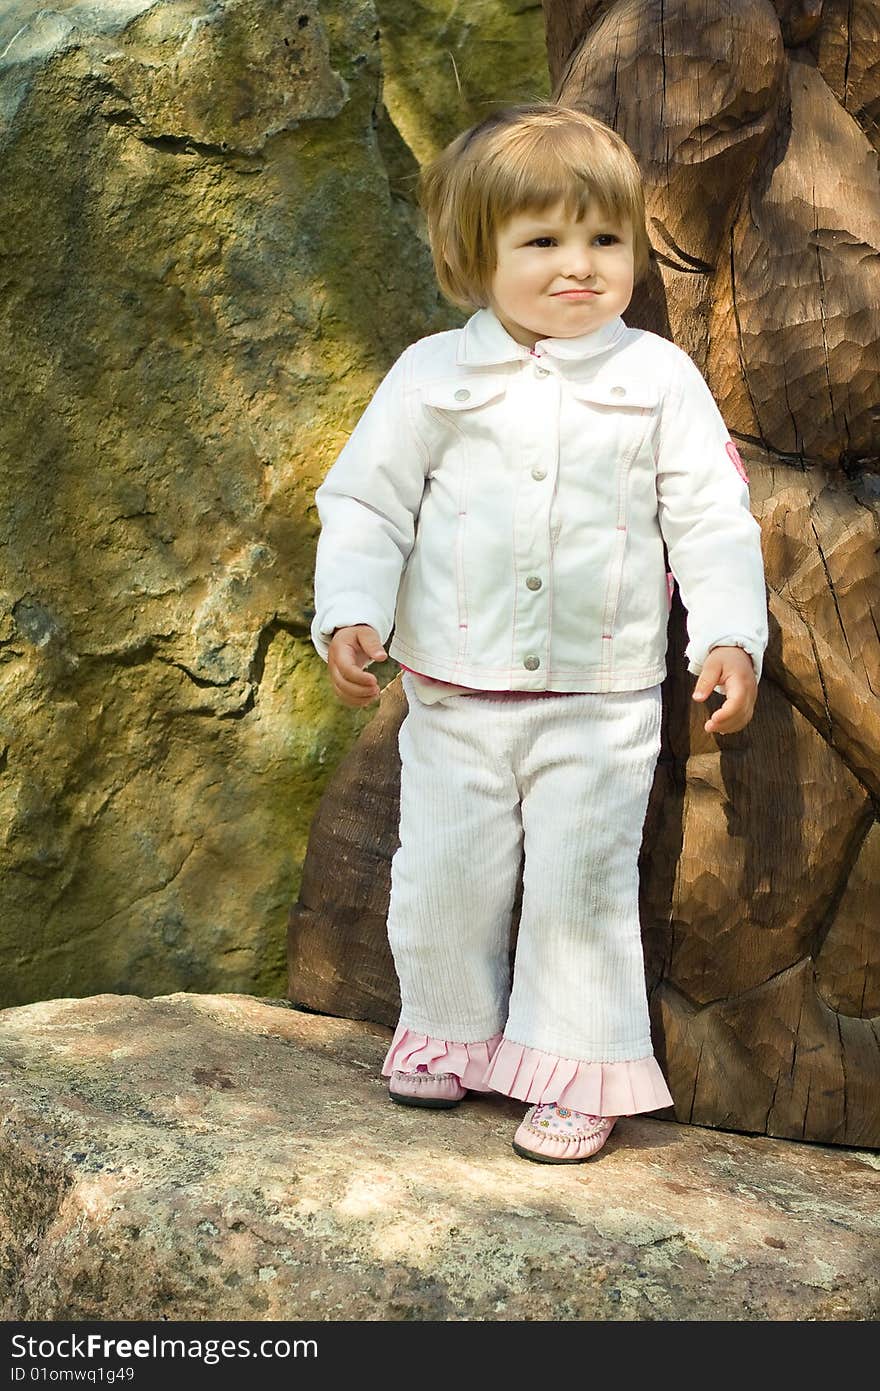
[0,995,880,1321]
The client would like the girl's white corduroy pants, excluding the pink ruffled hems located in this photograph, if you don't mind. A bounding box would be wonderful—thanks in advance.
[388,672,660,1063]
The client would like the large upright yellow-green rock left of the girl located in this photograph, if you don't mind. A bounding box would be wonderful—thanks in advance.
[0,0,459,1004]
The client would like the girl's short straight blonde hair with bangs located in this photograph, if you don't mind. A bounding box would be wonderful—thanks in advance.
[418,102,651,309]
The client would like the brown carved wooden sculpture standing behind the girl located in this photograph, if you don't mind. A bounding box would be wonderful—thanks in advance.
[291,0,880,1146]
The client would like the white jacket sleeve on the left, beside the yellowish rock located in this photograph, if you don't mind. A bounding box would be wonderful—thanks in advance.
[311,339,427,661]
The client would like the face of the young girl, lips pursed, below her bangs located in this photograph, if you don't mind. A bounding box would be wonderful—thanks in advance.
[489,203,634,348]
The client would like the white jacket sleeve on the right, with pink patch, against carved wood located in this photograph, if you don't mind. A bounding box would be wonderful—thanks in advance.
[656,349,767,690]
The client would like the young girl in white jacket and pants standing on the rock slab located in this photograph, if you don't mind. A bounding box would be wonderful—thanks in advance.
[311,103,767,1163]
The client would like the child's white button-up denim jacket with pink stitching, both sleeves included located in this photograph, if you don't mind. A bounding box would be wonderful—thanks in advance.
[311,309,767,691]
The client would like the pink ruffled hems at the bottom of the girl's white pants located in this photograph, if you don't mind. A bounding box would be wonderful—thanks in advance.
[382,1024,673,1116]
